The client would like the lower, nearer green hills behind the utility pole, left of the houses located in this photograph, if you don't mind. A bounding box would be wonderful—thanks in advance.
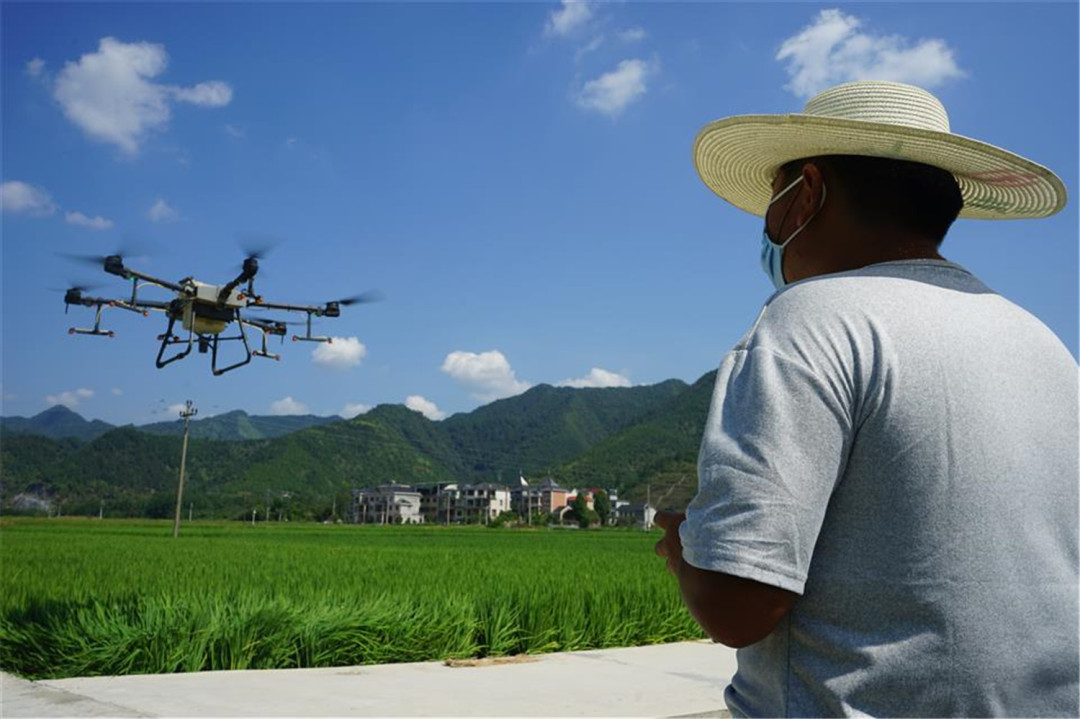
[0,420,450,517]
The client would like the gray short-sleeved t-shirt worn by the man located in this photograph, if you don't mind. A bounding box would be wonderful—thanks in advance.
[680,260,1080,717]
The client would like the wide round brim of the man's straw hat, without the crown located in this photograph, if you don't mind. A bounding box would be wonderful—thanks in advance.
[693,114,1067,219]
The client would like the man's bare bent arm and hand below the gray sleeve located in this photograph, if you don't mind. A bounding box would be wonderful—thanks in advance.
[656,512,799,648]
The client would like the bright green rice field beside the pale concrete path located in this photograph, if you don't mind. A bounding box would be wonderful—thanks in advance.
[0,518,704,679]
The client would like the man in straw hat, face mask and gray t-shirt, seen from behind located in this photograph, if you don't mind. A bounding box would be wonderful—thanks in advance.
[657,82,1080,717]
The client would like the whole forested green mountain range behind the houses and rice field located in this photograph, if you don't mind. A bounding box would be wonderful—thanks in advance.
[0,380,703,518]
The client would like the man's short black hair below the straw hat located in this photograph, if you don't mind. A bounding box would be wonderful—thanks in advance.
[781,154,963,244]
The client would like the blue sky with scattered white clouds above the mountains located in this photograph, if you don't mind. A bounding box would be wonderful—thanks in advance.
[0,2,1080,423]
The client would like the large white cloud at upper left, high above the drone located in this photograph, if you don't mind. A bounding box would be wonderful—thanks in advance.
[53,38,232,154]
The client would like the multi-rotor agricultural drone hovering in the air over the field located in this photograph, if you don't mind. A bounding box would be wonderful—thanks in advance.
[64,253,381,375]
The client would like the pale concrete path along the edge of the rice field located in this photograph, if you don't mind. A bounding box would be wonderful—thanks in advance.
[0,641,735,717]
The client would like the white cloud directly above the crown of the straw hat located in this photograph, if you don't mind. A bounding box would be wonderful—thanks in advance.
[777,9,964,97]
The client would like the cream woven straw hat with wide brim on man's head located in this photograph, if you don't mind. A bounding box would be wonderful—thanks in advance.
[693,81,1066,219]
